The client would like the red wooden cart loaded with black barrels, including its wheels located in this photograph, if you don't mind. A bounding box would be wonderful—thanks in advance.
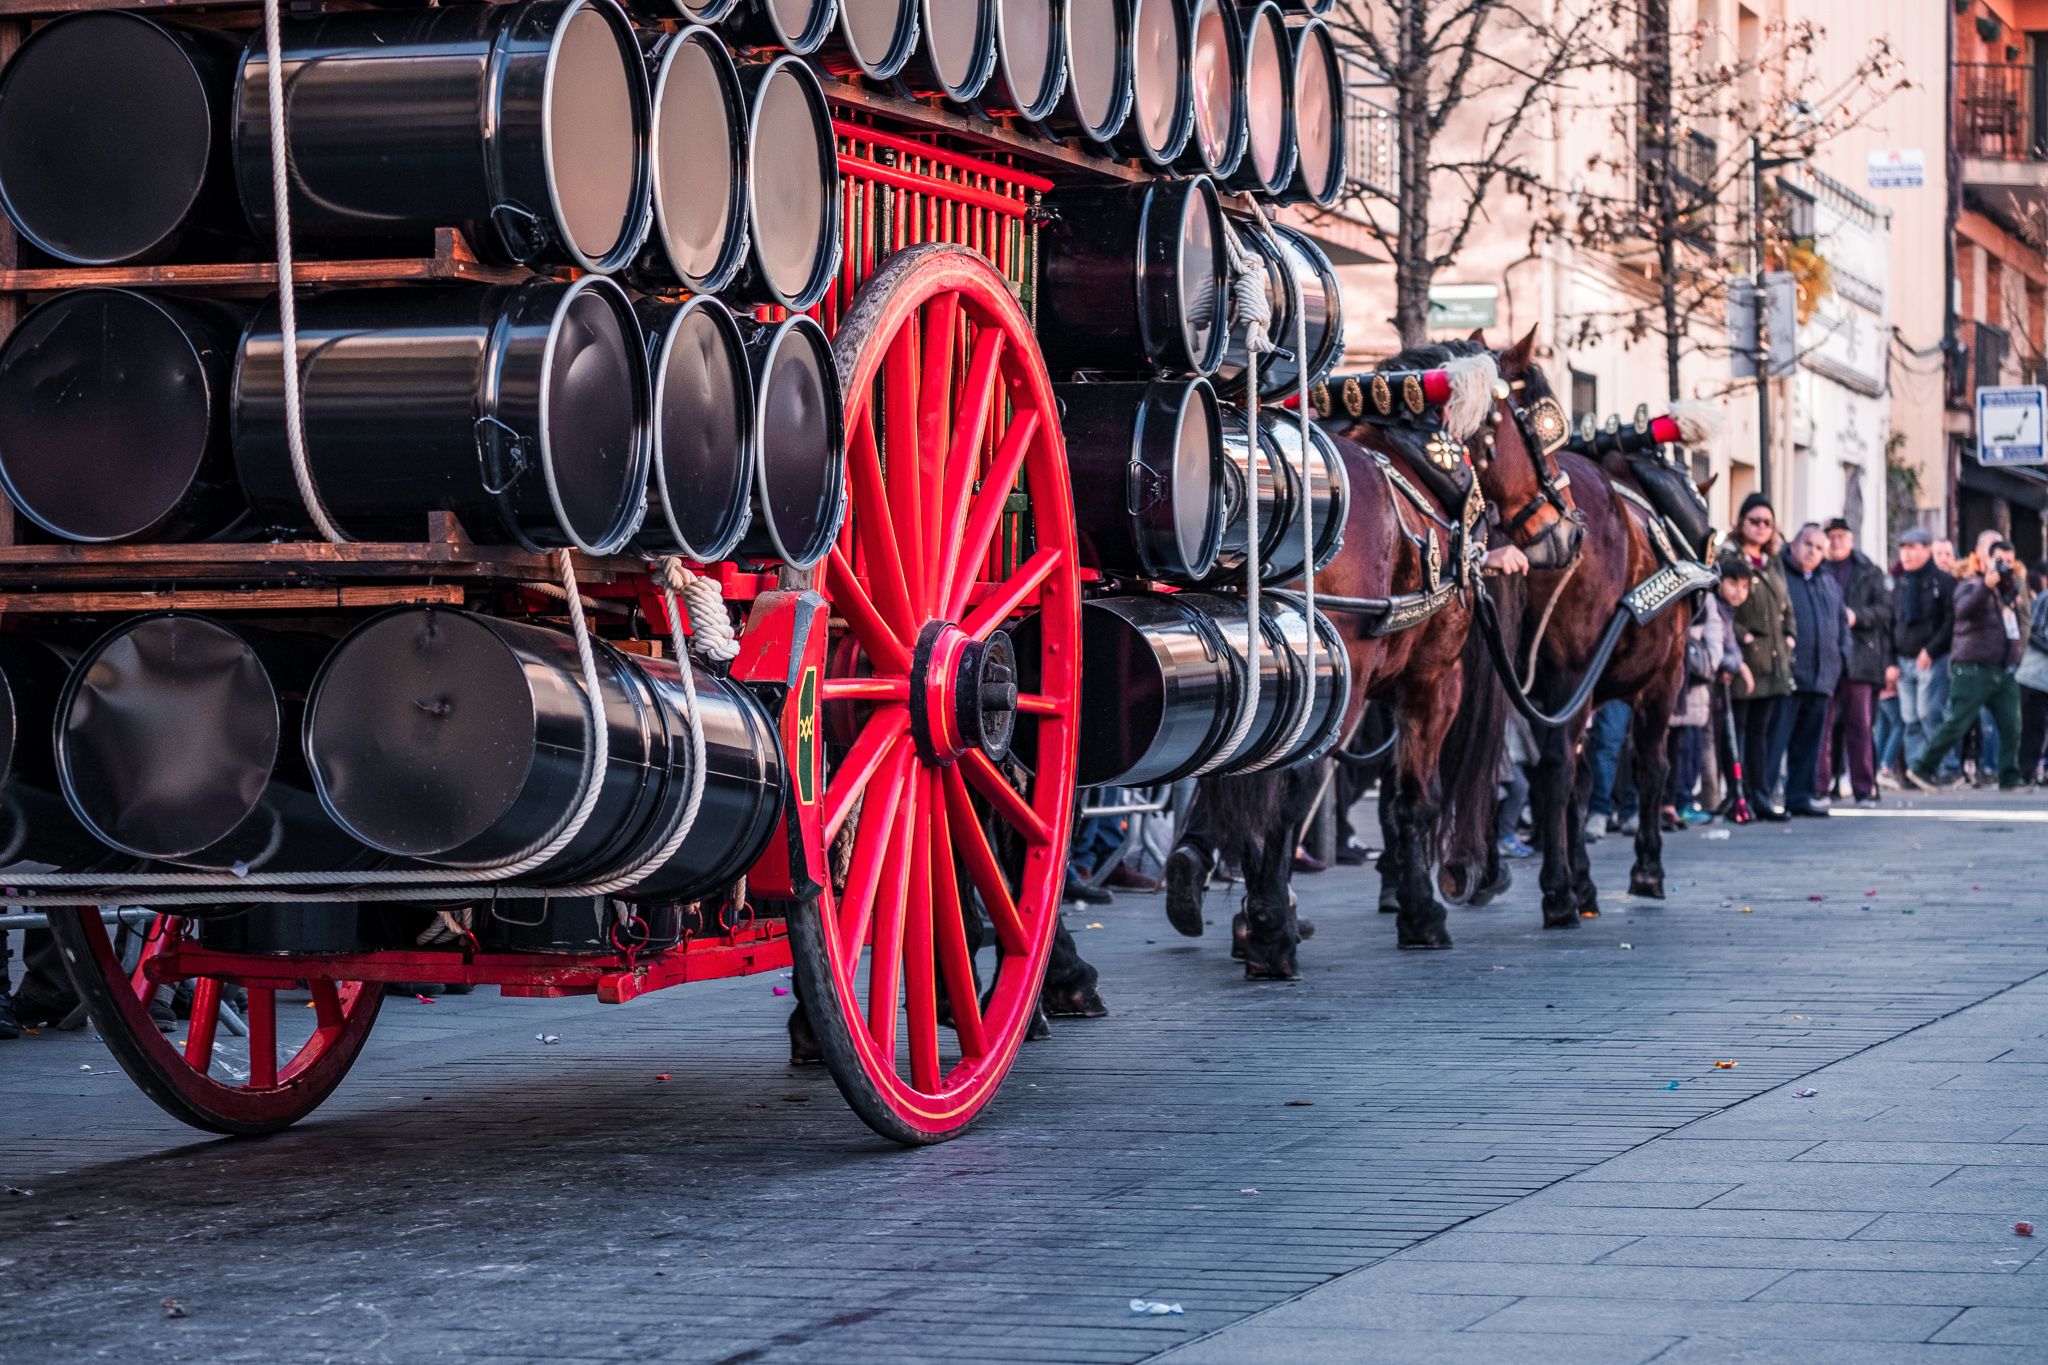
[0,0,1368,1142]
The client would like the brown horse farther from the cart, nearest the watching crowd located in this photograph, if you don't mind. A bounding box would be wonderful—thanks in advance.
[1474,332,1692,929]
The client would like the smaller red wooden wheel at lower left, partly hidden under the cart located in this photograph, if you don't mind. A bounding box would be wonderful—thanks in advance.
[49,911,383,1136]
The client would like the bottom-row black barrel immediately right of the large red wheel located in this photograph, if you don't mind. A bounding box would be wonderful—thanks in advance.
[1064,593,1239,786]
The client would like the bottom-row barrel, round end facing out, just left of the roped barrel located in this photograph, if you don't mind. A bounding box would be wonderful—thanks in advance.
[55,612,373,872]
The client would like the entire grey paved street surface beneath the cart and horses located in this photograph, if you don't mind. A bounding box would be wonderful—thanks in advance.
[0,796,2048,1365]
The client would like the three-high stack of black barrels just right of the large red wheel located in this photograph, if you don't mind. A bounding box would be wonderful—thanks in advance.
[1024,157,1350,786]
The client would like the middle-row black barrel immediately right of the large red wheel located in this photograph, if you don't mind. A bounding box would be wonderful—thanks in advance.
[1053,379,1225,583]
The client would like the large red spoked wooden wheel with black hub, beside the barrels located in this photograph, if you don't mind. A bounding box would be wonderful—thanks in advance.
[791,246,1081,1144]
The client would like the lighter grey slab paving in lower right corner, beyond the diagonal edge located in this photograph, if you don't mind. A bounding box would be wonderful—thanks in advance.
[1161,976,2048,1365]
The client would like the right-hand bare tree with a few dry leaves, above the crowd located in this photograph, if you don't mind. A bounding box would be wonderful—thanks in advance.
[1536,0,1911,399]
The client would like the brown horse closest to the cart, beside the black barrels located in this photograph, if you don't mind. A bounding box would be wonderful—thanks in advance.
[1167,358,1531,980]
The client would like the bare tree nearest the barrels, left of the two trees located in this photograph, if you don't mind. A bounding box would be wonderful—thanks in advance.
[1329,0,1612,346]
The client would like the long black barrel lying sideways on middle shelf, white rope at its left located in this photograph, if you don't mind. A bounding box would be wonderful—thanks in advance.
[233,276,649,555]
